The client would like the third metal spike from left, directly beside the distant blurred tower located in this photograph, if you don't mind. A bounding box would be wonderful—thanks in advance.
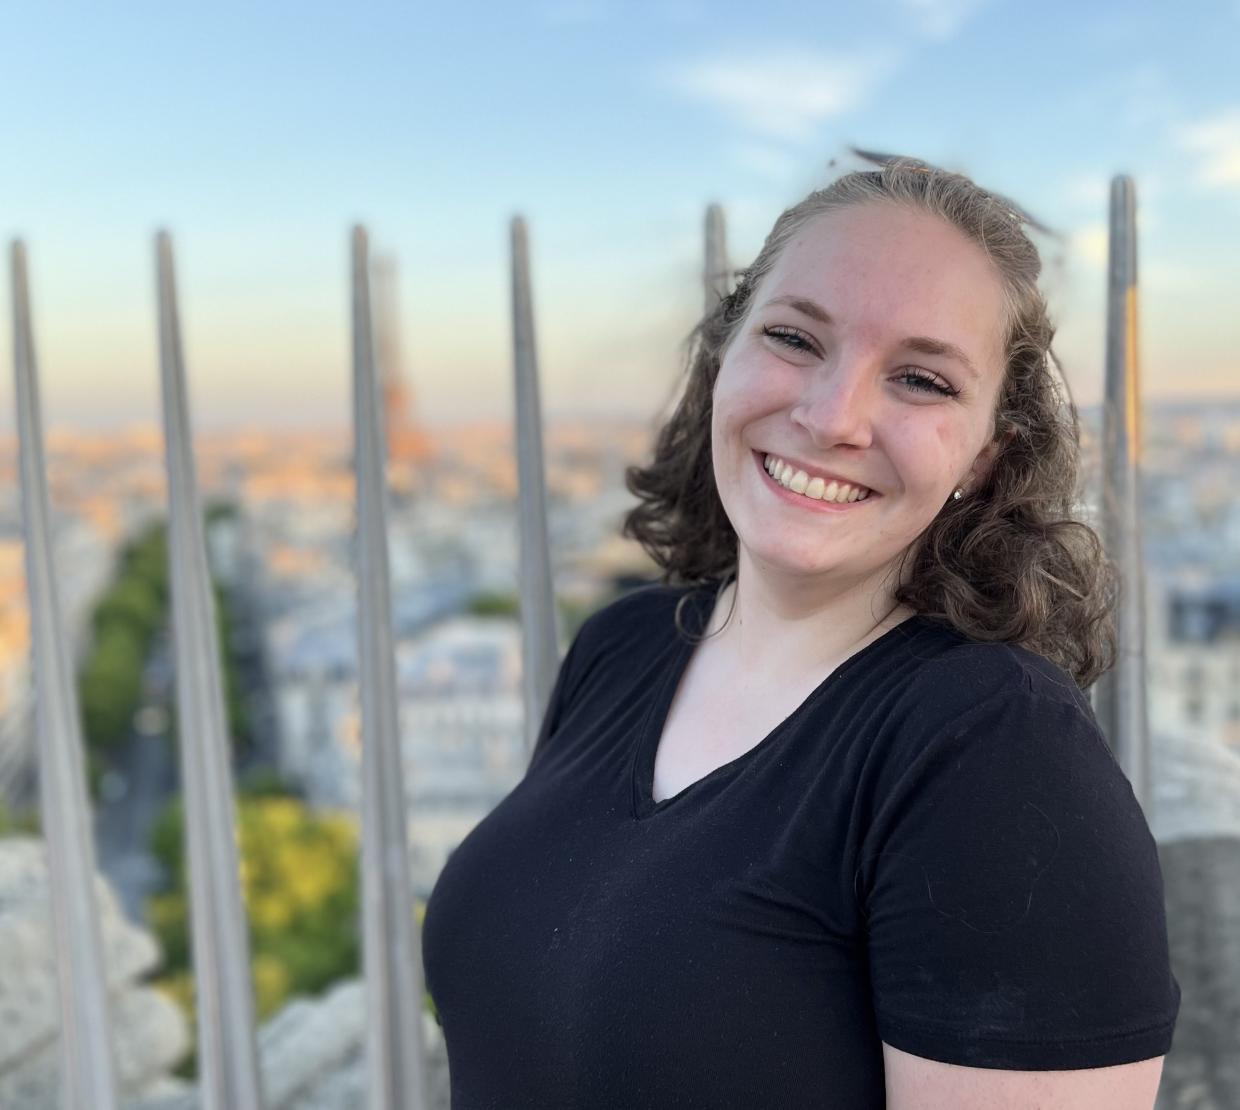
[351,227,428,1110]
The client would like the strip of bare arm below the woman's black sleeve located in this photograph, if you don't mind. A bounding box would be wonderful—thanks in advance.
[883,1042,1164,1110]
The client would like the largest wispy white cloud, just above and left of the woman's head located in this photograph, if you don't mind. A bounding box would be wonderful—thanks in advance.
[661,50,898,143]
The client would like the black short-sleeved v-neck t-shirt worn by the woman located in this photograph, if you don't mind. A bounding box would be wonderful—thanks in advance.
[423,582,1180,1110]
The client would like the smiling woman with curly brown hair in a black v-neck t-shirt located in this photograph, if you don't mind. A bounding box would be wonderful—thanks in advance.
[423,160,1179,1110]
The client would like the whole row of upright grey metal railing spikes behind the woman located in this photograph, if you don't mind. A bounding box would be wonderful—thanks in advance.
[12,179,1147,1110]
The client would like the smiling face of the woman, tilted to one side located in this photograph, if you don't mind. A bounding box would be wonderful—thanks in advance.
[711,203,1004,595]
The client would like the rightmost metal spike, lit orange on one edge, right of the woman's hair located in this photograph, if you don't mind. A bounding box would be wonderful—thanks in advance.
[1094,175,1149,805]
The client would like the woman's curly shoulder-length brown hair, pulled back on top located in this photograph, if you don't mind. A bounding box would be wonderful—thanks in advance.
[621,158,1117,688]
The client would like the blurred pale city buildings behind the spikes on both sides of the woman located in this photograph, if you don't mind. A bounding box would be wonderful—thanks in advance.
[9,391,1240,823]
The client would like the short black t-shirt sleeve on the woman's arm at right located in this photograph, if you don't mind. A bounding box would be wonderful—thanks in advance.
[856,688,1180,1070]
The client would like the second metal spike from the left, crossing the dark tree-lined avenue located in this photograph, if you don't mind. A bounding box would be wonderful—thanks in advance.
[155,232,263,1110]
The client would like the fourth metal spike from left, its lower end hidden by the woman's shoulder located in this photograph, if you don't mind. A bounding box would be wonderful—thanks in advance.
[511,216,559,755]
